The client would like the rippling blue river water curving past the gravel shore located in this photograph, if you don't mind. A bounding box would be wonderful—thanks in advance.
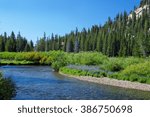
[0,66,150,100]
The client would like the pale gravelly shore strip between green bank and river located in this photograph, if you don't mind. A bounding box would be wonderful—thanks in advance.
[60,72,150,91]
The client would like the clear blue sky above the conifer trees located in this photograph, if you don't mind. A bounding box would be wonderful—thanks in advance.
[0,0,140,42]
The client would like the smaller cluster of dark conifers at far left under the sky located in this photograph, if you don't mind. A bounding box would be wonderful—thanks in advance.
[0,31,34,52]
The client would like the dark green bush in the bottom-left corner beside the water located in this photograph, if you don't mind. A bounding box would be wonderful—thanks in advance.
[0,73,16,100]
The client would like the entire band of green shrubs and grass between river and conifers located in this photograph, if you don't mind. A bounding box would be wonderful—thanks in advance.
[0,51,150,84]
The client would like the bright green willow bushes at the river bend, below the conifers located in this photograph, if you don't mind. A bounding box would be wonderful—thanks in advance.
[49,51,108,71]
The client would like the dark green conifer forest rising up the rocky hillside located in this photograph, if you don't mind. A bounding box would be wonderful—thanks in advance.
[0,0,150,57]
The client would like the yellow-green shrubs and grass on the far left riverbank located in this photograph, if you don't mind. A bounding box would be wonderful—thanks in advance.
[0,52,52,65]
